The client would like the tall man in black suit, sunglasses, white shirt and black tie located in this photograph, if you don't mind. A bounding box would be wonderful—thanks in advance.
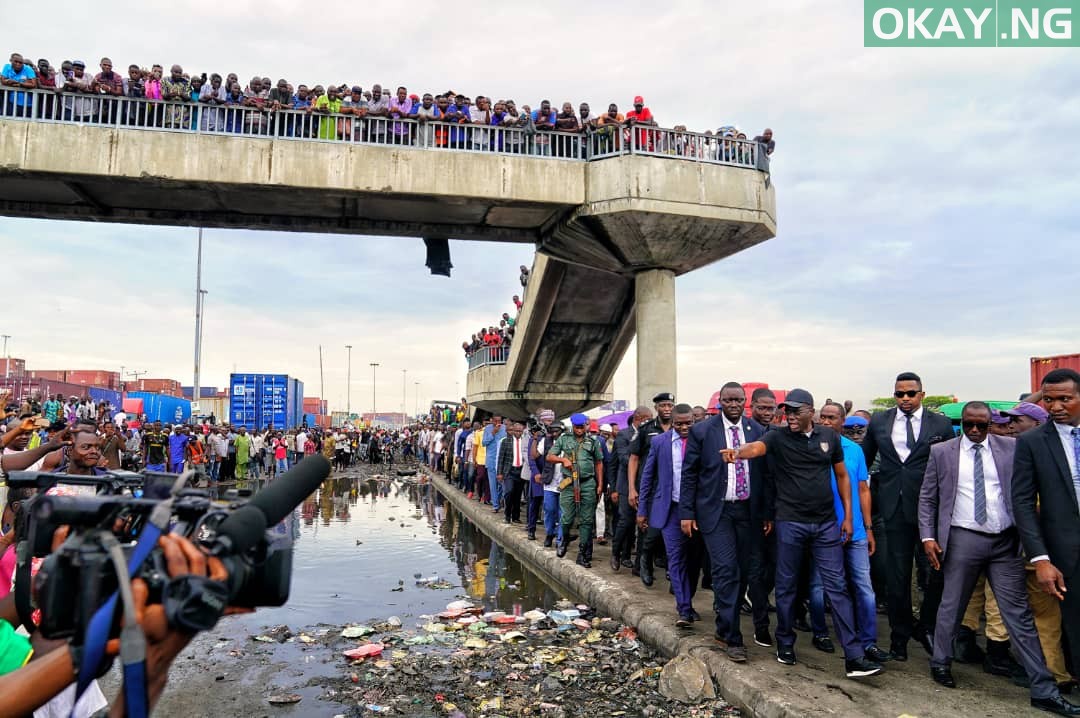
[863,371,954,661]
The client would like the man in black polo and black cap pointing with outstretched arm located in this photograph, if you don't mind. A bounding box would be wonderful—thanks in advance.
[720,389,882,678]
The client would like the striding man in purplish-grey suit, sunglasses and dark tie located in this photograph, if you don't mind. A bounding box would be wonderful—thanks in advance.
[919,402,1080,716]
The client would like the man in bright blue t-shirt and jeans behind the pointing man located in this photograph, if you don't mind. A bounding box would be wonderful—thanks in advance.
[810,404,889,663]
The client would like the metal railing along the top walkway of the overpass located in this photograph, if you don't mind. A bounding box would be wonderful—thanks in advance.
[0,87,768,171]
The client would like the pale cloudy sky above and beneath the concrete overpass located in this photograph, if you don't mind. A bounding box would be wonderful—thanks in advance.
[0,0,1080,411]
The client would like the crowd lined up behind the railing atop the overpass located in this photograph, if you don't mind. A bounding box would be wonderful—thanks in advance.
[0,53,775,159]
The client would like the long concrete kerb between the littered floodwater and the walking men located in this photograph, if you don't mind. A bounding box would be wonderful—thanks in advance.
[431,476,812,718]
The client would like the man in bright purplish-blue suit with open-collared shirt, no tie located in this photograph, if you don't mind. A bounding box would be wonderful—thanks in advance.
[637,404,700,628]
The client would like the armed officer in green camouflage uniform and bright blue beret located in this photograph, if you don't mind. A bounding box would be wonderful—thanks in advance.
[548,414,604,568]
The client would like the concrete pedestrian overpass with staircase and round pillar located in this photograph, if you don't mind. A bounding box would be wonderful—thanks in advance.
[0,89,777,415]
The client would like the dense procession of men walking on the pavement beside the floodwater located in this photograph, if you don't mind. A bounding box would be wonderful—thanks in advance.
[415,369,1080,716]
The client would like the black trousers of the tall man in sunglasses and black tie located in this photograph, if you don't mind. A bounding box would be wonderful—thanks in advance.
[885,512,944,644]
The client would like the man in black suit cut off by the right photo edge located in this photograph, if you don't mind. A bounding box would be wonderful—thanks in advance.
[1012,369,1080,691]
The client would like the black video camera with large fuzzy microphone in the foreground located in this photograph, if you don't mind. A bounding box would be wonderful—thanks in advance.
[9,456,330,647]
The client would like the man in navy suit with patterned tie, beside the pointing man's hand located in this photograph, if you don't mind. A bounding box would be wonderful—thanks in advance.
[679,381,771,663]
